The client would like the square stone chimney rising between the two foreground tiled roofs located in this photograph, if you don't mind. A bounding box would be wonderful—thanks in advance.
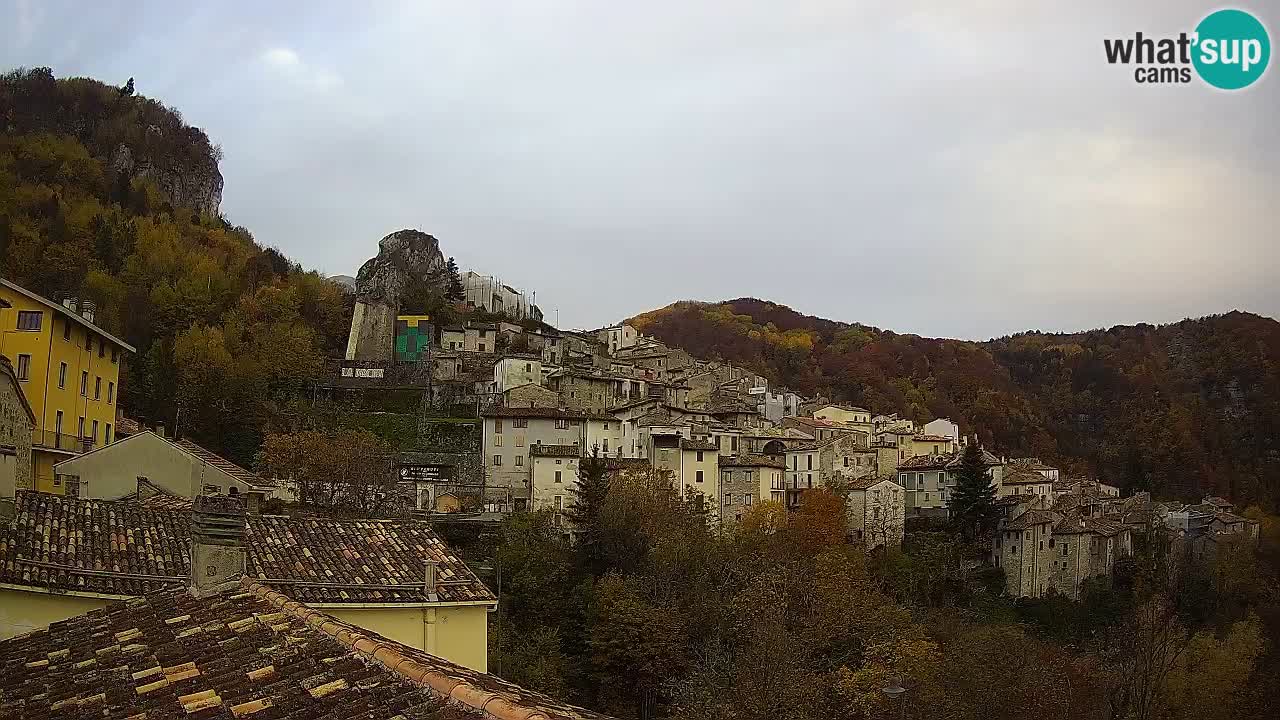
[191,495,247,597]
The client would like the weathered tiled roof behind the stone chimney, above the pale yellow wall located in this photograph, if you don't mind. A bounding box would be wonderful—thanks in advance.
[0,491,494,603]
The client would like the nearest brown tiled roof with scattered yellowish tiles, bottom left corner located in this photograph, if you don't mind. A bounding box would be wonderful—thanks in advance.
[0,579,614,720]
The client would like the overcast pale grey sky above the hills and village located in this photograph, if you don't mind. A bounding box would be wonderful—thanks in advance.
[0,0,1280,340]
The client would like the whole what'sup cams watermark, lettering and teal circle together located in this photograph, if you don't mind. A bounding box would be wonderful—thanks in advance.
[1102,9,1271,90]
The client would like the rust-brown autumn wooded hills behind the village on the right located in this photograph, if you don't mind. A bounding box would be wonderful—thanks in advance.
[631,299,1280,509]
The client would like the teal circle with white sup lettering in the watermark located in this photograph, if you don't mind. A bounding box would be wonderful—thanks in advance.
[1192,10,1271,90]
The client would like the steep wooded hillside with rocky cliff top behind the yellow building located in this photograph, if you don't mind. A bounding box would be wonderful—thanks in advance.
[0,68,351,462]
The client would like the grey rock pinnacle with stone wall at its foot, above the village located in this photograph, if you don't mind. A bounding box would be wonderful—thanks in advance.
[347,229,448,363]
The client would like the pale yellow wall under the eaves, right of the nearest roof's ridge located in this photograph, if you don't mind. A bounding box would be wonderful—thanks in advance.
[320,605,489,673]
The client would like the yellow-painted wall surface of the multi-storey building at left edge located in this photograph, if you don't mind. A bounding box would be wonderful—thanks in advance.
[0,286,125,493]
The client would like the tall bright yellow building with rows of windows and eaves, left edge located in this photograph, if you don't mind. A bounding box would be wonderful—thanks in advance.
[0,278,134,495]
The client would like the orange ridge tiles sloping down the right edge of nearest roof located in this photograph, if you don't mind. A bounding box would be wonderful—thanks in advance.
[239,575,552,720]
